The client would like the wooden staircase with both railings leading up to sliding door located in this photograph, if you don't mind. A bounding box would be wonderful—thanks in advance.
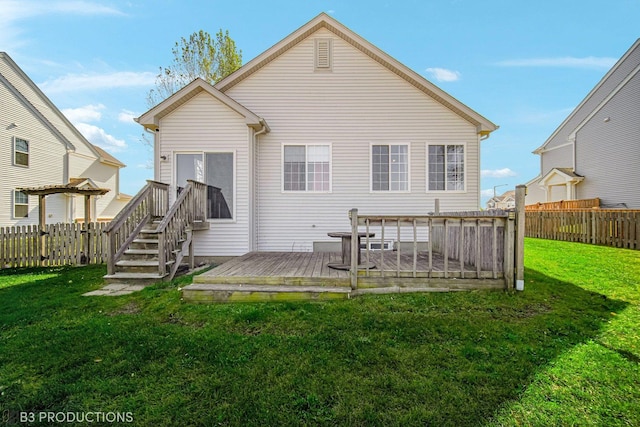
[104,181,209,285]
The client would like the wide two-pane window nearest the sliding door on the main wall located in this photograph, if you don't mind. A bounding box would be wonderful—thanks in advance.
[282,145,331,191]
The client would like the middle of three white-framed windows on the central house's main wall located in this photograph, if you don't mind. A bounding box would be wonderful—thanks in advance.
[371,145,409,191]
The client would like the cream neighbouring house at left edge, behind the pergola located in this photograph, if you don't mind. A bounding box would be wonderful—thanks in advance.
[0,52,131,226]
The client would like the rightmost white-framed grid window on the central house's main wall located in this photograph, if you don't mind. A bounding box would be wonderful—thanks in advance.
[427,144,464,191]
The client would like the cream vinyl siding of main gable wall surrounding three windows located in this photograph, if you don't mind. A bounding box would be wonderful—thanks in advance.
[226,29,479,251]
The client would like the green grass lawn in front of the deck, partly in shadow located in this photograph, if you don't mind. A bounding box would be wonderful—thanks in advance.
[0,239,640,426]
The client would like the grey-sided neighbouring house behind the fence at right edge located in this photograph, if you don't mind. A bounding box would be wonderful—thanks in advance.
[526,39,640,209]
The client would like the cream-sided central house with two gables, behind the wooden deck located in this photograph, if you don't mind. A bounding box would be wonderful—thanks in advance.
[137,13,497,257]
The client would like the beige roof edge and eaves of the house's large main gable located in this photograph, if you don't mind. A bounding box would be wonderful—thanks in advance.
[214,13,498,136]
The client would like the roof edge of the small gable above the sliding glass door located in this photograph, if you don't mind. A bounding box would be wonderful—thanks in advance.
[135,77,269,131]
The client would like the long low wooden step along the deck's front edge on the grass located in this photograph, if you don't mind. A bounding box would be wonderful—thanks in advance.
[182,283,351,304]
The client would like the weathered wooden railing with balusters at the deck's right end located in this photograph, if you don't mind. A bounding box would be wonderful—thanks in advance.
[349,186,524,289]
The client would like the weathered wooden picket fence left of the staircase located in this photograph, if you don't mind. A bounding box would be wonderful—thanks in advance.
[0,223,107,268]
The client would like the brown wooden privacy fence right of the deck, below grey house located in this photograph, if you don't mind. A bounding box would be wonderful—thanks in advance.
[525,209,640,249]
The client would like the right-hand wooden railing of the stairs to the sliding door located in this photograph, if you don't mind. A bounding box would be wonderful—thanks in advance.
[156,180,207,280]
